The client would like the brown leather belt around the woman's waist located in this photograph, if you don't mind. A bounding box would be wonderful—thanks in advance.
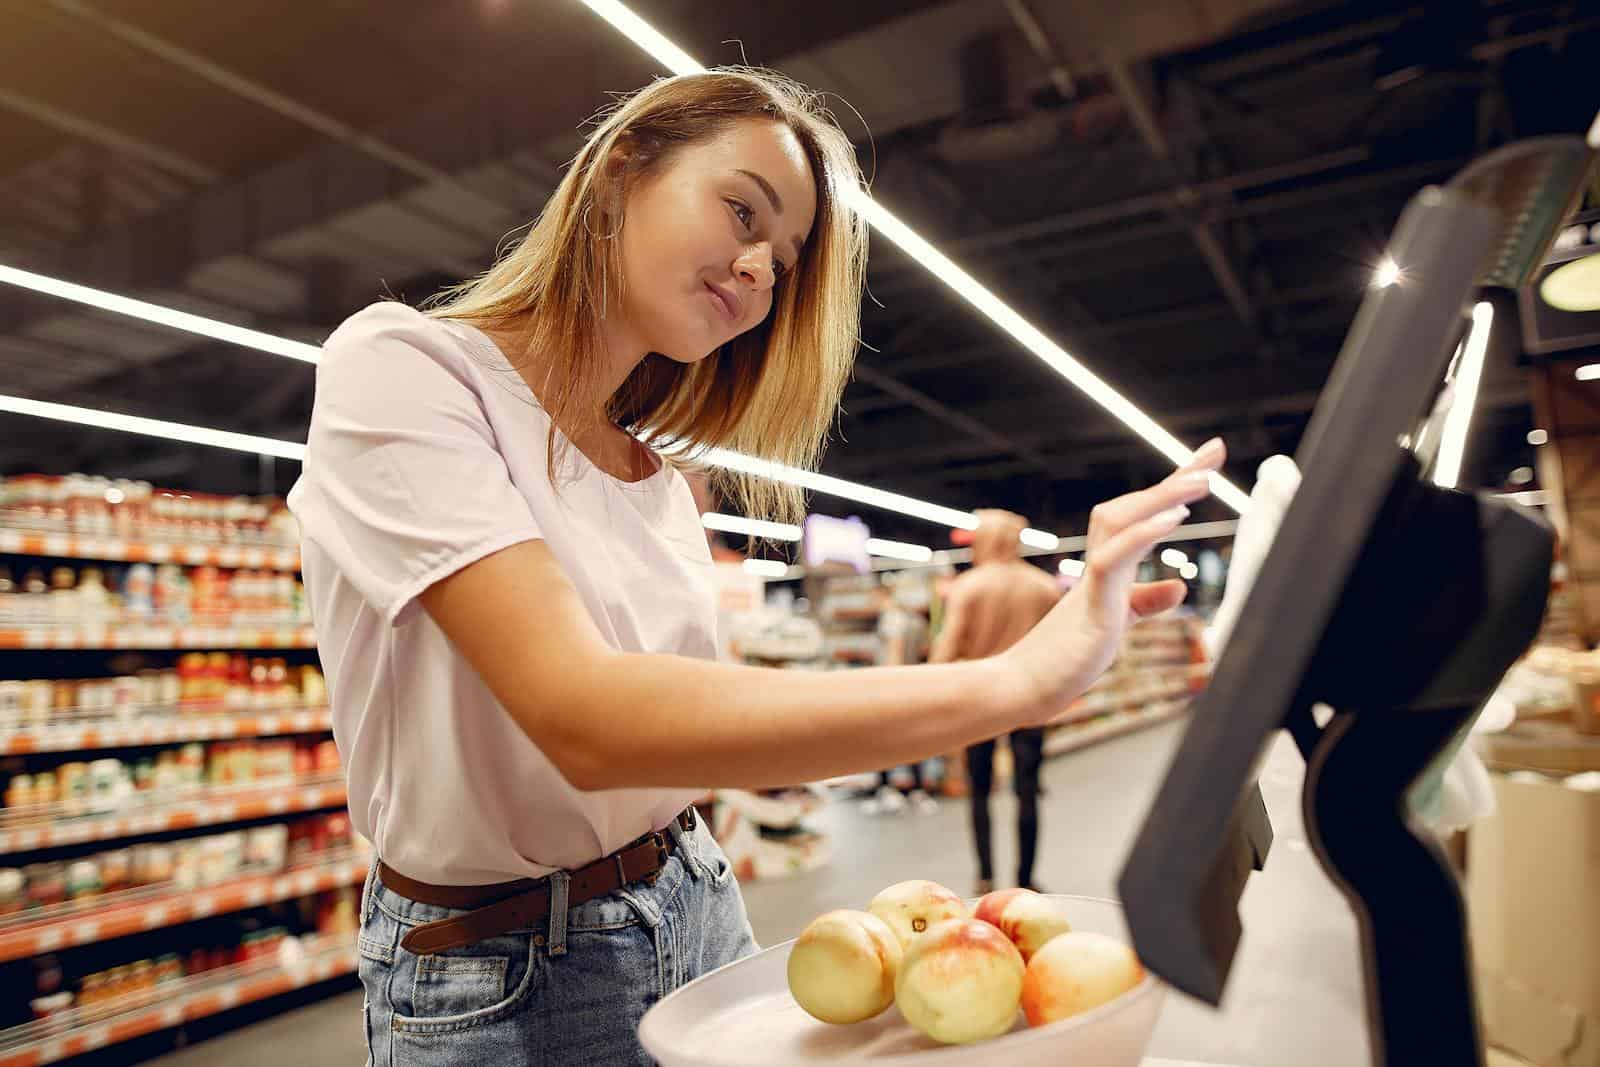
[378,806,694,955]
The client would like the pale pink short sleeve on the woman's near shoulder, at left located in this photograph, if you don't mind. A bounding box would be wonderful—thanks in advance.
[290,304,541,625]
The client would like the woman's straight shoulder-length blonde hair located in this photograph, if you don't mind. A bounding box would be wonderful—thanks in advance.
[429,69,867,520]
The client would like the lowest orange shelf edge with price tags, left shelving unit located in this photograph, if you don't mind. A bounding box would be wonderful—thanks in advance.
[0,934,355,1067]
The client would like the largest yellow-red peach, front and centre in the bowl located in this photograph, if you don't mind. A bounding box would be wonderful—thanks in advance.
[894,918,1026,1045]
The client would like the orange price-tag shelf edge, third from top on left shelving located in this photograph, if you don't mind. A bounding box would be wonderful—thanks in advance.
[0,707,333,755]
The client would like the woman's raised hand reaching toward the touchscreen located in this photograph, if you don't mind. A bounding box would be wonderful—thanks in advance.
[1000,438,1227,723]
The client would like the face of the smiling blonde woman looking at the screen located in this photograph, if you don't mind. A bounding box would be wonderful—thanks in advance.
[608,118,816,363]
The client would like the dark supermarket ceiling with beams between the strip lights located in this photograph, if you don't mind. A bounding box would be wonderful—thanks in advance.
[0,0,1600,542]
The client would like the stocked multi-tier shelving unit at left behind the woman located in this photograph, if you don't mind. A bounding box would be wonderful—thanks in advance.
[0,498,356,1067]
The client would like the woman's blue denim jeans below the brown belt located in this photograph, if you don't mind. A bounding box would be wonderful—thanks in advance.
[358,822,757,1067]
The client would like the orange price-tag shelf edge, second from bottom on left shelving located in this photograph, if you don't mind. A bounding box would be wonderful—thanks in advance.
[0,851,368,963]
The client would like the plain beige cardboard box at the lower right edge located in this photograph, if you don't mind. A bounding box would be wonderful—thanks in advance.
[1467,774,1600,1067]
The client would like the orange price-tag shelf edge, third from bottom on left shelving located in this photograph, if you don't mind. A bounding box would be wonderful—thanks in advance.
[0,776,346,854]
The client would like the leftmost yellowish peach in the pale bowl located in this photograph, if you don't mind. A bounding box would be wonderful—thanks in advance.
[789,909,902,1022]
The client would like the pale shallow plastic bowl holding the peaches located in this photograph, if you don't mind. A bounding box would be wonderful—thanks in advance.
[638,896,1166,1067]
